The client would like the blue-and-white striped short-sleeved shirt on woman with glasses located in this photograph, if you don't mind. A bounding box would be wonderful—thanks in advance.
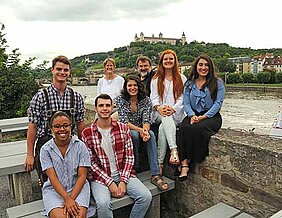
[40,136,90,192]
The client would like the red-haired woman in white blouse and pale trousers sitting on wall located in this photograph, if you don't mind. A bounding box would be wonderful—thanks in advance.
[150,50,187,174]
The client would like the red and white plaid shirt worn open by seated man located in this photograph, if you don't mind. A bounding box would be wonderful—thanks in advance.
[82,120,135,186]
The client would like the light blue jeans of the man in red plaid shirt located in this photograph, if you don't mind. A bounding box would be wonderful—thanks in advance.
[91,176,152,218]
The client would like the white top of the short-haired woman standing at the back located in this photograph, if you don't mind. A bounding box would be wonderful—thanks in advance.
[97,75,124,100]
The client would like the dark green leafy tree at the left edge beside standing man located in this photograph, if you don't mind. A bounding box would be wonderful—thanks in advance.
[0,24,39,119]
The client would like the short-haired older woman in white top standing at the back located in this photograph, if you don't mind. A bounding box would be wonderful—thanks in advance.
[97,58,124,100]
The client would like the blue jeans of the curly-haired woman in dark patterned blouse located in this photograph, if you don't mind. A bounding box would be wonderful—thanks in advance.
[130,130,160,176]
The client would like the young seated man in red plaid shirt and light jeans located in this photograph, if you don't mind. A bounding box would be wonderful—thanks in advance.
[82,94,152,218]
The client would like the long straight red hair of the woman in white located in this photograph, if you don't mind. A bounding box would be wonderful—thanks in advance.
[153,49,183,102]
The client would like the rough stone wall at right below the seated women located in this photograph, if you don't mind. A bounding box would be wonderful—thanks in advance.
[161,129,282,217]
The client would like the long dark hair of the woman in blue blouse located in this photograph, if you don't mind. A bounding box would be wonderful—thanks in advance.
[189,55,218,100]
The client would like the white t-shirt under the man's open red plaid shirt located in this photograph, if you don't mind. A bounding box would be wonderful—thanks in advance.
[98,127,119,177]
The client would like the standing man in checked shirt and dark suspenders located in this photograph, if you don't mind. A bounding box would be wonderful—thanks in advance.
[25,56,85,185]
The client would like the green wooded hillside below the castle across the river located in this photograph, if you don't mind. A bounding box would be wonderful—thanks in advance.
[72,41,282,76]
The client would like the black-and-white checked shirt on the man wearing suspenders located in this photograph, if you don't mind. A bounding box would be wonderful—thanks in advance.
[27,84,84,138]
